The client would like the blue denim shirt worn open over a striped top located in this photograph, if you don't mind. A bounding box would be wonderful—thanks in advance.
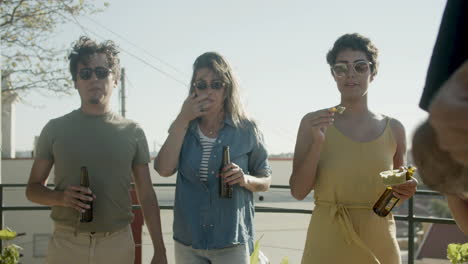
[173,119,271,252]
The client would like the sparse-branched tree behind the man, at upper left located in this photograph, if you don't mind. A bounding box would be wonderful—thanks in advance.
[0,0,108,97]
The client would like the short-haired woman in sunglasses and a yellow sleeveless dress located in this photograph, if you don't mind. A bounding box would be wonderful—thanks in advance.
[290,34,417,264]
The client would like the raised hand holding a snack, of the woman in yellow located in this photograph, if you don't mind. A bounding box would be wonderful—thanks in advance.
[302,108,335,142]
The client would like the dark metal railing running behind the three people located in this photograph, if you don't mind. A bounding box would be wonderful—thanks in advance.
[0,183,455,264]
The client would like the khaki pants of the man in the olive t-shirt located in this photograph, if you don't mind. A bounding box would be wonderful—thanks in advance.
[46,225,135,264]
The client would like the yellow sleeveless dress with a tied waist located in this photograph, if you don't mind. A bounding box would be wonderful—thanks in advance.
[302,118,401,264]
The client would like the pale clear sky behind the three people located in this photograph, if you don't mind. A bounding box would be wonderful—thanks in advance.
[11,0,445,154]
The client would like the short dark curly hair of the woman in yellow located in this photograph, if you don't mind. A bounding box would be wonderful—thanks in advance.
[327,33,379,77]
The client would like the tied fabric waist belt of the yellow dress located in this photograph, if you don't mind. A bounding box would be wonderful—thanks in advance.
[315,200,380,264]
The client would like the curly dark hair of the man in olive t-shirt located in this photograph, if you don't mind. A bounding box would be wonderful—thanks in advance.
[68,36,120,82]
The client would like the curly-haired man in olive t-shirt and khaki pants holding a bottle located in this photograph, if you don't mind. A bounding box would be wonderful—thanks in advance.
[26,37,167,264]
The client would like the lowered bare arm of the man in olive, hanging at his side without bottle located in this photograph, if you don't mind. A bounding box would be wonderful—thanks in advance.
[133,164,167,264]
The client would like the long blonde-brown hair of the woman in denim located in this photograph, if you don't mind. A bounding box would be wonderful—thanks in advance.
[189,52,252,127]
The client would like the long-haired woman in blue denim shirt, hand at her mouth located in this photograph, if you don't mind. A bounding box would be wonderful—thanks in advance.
[154,52,271,264]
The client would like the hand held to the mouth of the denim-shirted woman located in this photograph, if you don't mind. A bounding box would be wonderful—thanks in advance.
[179,93,213,122]
